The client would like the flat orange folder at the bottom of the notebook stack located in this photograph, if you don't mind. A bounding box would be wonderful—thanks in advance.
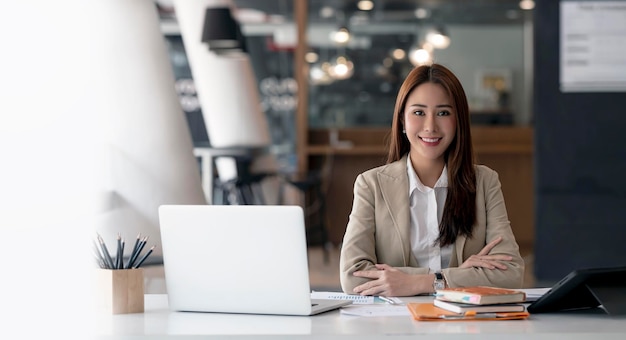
[407,302,530,321]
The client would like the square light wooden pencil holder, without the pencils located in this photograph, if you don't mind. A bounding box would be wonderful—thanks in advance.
[97,268,144,314]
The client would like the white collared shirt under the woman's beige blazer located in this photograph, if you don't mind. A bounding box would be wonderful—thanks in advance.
[407,156,452,273]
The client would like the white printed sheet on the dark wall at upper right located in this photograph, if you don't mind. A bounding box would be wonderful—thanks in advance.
[560,0,626,92]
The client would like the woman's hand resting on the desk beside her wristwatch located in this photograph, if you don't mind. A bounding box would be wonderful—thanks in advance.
[353,264,424,296]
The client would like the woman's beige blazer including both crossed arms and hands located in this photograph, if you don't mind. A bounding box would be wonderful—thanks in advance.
[340,168,524,296]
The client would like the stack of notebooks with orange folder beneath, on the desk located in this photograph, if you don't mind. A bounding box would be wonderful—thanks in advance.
[408,286,528,320]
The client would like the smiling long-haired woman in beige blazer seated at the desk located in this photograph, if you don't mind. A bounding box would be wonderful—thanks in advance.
[340,64,524,296]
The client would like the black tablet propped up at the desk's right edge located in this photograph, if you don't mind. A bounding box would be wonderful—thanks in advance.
[527,267,626,314]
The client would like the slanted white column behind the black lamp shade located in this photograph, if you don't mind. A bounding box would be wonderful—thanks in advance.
[173,0,277,201]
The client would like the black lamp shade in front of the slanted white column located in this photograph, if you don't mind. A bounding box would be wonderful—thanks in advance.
[202,7,246,54]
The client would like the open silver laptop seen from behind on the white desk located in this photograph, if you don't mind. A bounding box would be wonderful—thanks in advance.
[159,205,351,315]
